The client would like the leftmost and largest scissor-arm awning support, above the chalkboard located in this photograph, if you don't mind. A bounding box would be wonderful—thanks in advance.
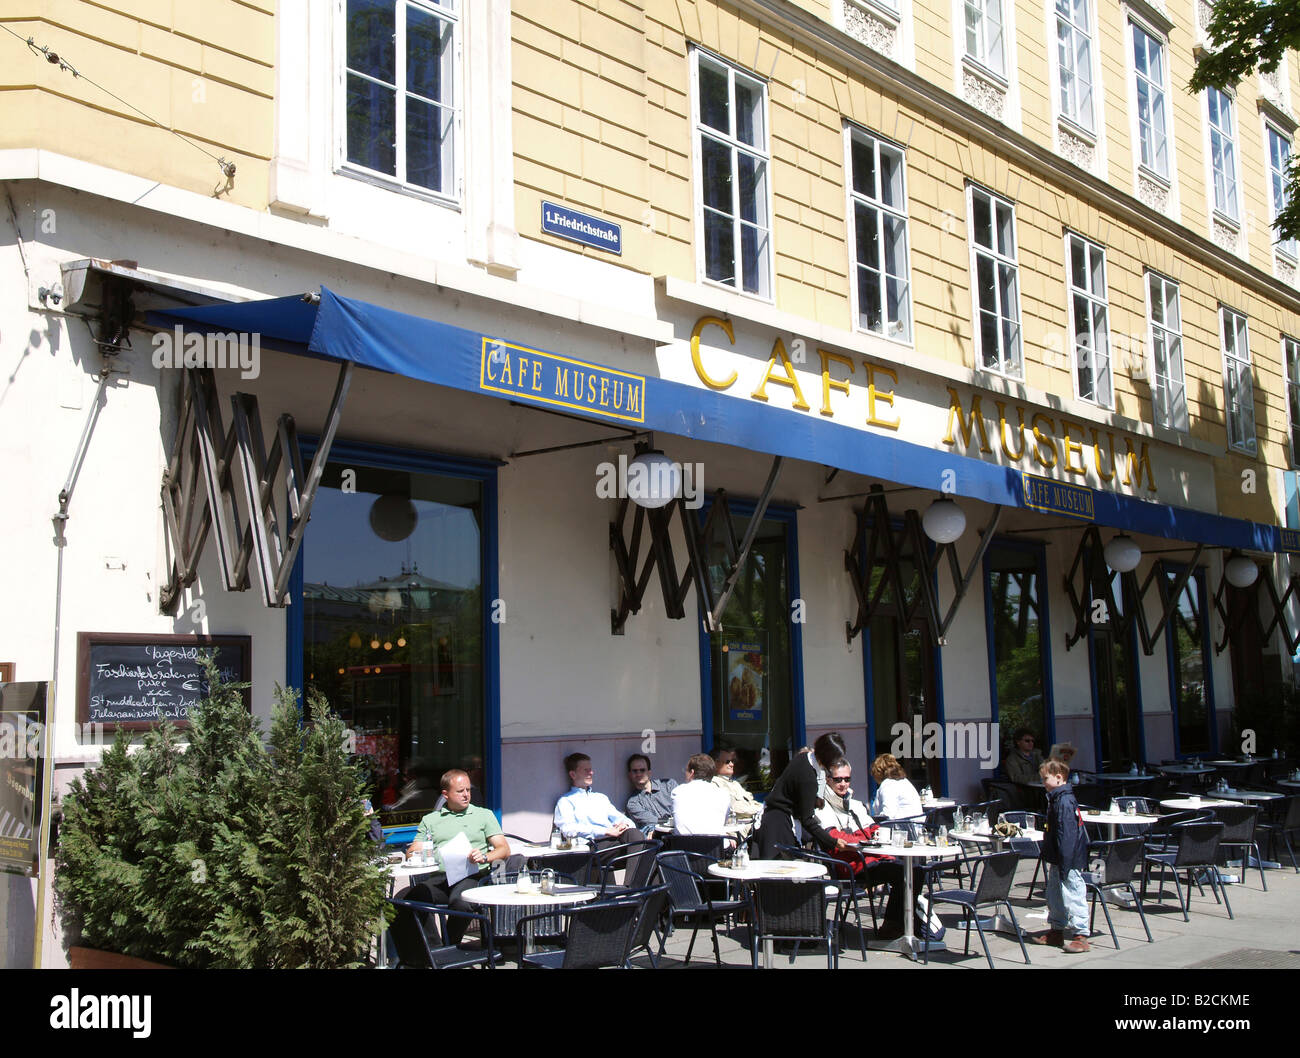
[159,361,355,615]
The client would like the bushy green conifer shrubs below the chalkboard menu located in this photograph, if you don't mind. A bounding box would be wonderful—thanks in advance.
[55,665,386,968]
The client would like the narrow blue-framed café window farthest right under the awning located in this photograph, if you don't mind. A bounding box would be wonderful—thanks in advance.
[1161,563,1216,756]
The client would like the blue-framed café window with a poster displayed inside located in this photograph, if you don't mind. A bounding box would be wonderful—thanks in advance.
[701,500,803,793]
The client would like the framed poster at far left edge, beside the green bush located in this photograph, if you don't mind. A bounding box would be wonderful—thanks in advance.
[0,682,49,877]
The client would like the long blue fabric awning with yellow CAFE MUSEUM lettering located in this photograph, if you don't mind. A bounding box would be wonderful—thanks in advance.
[148,287,1300,551]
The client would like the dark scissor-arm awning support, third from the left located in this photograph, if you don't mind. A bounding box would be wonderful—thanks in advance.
[844,485,1002,646]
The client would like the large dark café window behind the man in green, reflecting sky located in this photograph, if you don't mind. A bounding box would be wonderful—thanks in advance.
[290,445,501,823]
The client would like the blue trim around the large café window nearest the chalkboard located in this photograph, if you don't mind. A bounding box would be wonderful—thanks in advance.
[285,435,502,819]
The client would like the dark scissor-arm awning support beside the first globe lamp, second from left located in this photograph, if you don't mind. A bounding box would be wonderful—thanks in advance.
[610,456,785,636]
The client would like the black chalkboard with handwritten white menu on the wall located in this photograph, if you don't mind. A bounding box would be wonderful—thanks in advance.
[77,632,252,730]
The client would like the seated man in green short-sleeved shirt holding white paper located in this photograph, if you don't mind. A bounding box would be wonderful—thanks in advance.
[407,768,510,944]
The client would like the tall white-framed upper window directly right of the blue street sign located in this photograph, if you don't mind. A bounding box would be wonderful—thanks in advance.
[696,51,772,298]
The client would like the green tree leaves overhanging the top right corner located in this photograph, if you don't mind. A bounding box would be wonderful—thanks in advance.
[1188,0,1300,239]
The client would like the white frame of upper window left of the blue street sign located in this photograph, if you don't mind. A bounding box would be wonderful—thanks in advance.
[334,0,465,205]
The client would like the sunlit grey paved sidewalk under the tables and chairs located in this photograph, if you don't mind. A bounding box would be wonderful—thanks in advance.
[638,864,1300,971]
